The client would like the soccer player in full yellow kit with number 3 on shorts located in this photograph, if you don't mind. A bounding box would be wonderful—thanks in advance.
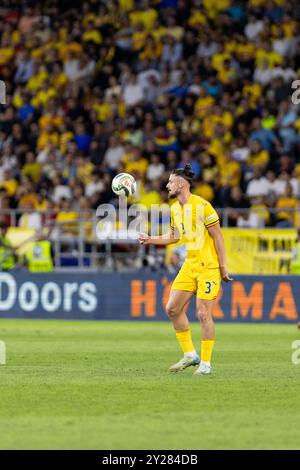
[139,165,232,375]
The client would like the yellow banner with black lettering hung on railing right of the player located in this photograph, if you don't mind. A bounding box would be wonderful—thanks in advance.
[222,228,297,274]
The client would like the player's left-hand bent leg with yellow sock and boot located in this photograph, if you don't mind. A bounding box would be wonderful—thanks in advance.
[166,289,200,372]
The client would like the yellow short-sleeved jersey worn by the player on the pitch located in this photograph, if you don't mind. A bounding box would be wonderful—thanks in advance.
[171,194,219,271]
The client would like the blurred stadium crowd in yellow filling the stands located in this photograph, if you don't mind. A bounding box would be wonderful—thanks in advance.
[0,0,300,233]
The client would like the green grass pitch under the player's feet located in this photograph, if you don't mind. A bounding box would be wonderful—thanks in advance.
[0,319,300,450]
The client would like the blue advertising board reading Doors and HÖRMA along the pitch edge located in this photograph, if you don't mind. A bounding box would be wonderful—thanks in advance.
[0,271,300,323]
